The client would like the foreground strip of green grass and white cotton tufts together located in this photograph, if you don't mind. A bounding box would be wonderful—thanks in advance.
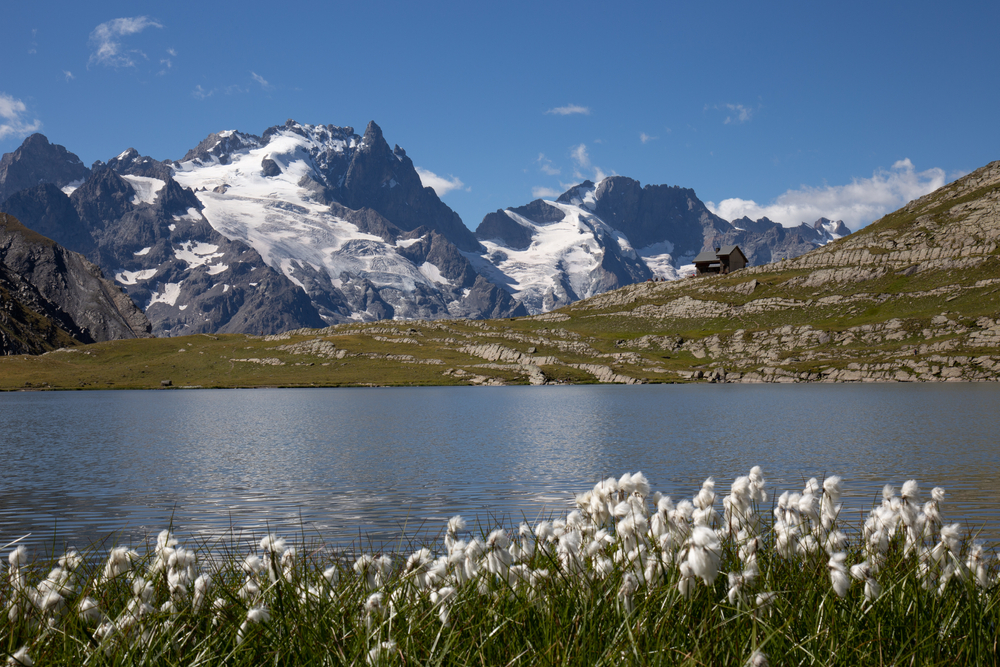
[0,467,1000,666]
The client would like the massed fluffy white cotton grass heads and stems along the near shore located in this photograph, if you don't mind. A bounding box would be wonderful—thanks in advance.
[7,468,998,665]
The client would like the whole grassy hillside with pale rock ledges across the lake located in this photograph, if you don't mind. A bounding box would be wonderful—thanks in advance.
[0,162,1000,389]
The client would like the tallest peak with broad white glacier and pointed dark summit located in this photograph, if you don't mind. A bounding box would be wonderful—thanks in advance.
[172,121,516,323]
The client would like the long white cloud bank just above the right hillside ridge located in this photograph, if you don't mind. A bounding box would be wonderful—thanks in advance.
[705,158,945,230]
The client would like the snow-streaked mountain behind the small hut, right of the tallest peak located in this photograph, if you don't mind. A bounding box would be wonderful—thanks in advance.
[466,176,850,313]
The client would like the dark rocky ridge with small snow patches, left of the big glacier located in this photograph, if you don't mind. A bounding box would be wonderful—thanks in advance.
[0,152,325,340]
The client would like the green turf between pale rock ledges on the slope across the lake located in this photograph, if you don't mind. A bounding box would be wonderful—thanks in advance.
[0,162,1000,390]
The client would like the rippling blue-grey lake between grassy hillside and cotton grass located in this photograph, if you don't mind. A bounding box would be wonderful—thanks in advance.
[0,384,1000,551]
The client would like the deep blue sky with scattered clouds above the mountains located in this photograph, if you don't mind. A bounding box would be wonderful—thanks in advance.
[0,0,1000,228]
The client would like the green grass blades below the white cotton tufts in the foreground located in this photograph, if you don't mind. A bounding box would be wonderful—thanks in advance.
[0,472,1000,665]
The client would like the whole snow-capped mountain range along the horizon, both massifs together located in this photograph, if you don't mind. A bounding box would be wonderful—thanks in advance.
[0,120,848,335]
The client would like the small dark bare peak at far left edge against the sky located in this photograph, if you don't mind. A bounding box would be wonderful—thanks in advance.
[0,134,89,201]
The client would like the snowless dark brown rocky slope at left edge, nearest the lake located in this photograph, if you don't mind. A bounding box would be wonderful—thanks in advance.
[0,214,151,354]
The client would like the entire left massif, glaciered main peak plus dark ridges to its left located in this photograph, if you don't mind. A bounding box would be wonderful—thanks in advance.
[0,121,525,335]
